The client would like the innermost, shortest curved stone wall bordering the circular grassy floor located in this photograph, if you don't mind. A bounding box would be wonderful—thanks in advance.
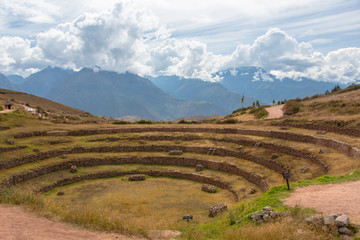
[38,170,238,201]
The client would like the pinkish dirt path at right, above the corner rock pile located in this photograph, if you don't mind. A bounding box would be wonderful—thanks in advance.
[283,181,360,224]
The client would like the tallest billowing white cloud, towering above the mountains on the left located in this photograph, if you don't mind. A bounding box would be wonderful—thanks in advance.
[37,2,165,74]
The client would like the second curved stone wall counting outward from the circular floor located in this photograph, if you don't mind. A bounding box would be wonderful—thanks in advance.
[0,157,268,192]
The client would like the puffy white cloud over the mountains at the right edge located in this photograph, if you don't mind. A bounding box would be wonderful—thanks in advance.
[224,28,360,83]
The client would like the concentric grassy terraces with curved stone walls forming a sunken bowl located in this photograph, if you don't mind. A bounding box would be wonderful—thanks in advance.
[0,124,360,230]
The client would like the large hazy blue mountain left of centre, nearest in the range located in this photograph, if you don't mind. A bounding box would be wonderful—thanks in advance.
[47,69,227,120]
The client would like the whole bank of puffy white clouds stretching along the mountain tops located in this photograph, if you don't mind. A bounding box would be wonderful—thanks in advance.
[0,1,360,83]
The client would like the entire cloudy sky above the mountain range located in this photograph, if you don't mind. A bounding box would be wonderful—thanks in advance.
[0,0,360,83]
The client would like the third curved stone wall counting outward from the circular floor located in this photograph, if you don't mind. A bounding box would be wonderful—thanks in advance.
[0,145,289,178]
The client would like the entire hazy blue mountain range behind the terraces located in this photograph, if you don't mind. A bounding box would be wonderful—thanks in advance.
[0,67,344,120]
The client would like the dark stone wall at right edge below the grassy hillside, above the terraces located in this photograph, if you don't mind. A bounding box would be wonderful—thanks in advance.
[273,122,360,137]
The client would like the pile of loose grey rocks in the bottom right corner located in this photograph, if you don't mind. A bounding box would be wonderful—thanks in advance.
[305,214,354,239]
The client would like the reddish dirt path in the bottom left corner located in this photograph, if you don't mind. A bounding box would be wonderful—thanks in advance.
[0,205,145,240]
